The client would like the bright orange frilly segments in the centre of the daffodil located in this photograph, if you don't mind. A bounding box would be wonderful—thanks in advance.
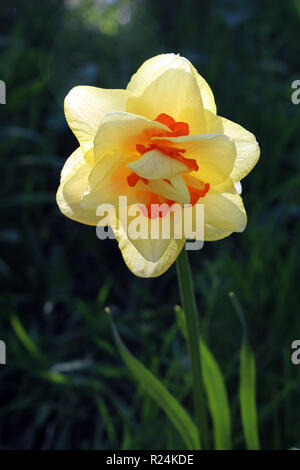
[127,113,210,219]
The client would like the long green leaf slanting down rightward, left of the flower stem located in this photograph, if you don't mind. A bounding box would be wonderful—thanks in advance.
[109,316,199,450]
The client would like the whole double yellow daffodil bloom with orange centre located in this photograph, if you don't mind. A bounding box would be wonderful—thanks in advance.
[57,54,259,277]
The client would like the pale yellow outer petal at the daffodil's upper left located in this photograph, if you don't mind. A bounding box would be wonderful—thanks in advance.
[65,86,129,151]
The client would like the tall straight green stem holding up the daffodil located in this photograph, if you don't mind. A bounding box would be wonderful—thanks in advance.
[176,247,208,449]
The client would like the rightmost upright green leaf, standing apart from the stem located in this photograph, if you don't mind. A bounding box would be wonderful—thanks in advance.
[240,336,259,450]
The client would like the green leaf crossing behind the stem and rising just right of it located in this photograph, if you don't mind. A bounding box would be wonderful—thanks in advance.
[175,306,231,450]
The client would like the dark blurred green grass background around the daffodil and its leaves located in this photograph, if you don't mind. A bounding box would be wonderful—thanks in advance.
[0,0,300,449]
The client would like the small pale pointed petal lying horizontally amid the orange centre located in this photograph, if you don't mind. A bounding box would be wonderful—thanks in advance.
[128,150,189,180]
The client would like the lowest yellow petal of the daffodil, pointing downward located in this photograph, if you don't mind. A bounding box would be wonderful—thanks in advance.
[112,214,185,277]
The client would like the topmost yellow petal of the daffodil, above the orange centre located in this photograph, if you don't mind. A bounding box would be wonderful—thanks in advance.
[126,54,206,134]
